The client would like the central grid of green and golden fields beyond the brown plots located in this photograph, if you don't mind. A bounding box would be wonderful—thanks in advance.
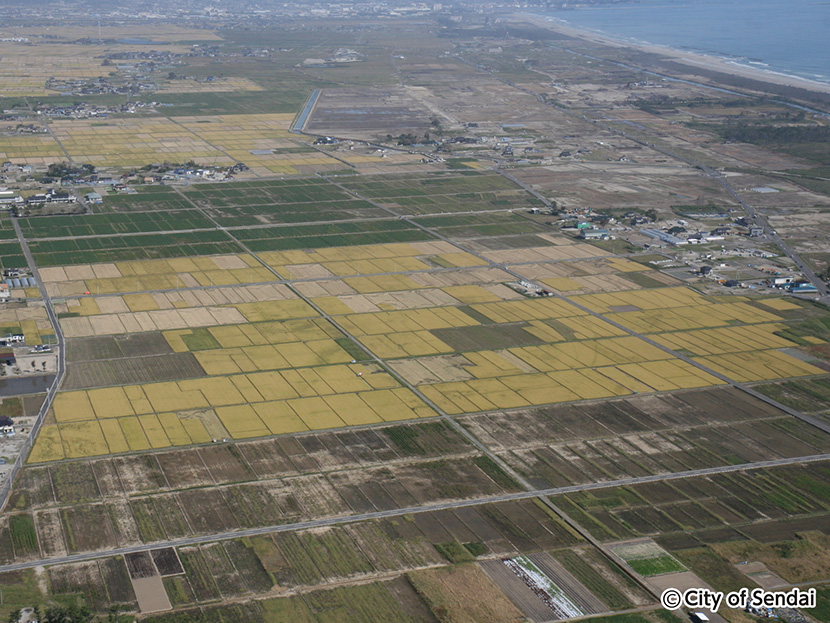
[22,168,824,461]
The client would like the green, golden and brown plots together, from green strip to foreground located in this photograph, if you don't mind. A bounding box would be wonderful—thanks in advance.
[9,161,828,621]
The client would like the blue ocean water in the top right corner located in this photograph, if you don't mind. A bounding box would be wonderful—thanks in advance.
[537,0,830,83]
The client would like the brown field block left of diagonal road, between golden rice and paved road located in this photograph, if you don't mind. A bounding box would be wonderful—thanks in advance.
[3,424,532,564]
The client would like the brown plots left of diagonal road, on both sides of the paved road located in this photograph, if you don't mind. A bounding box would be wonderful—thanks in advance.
[0,416,664,623]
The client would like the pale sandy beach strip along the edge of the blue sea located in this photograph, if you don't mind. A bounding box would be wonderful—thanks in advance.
[508,13,830,94]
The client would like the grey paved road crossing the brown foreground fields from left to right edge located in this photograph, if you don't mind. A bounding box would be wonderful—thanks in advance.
[0,454,830,573]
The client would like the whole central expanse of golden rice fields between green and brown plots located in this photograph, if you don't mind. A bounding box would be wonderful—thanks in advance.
[30,242,823,461]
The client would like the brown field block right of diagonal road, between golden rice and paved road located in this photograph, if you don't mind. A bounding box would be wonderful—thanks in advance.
[460,388,830,492]
